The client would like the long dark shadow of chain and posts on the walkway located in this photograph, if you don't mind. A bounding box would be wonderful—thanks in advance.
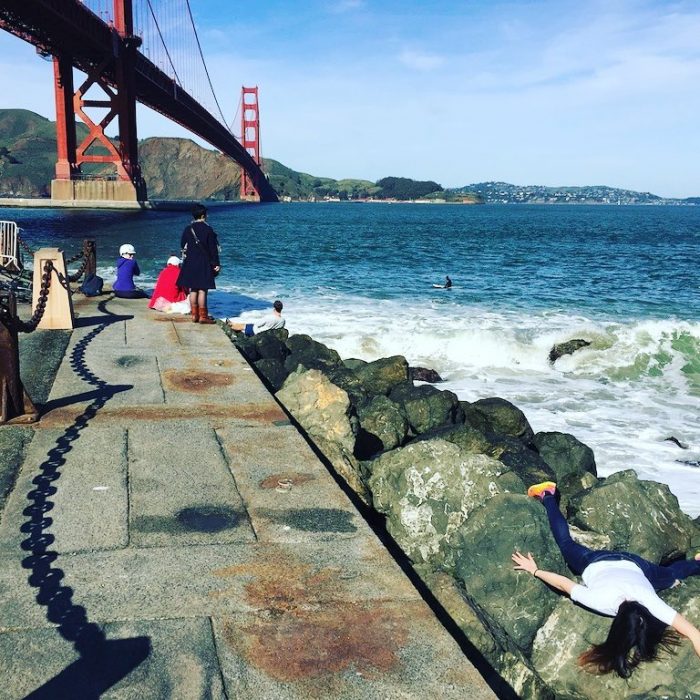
[20,299,151,700]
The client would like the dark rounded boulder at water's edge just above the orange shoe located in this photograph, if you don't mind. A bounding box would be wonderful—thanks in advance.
[533,432,598,493]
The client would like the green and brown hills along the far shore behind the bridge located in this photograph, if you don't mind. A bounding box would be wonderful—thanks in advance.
[0,109,700,204]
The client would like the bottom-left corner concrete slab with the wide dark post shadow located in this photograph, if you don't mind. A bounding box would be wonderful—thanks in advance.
[0,618,226,700]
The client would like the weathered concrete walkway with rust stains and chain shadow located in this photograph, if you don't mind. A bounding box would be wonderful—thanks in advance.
[0,299,494,700]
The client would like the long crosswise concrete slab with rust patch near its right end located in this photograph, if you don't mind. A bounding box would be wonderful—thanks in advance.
[0,538,417,631]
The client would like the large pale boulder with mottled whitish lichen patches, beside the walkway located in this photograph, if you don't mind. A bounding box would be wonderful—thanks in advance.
[369,440,522,569]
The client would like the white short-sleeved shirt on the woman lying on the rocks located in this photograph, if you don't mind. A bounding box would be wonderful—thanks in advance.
[571,560,676,625]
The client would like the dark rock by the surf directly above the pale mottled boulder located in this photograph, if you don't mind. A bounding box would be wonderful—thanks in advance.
[389,380,464,434]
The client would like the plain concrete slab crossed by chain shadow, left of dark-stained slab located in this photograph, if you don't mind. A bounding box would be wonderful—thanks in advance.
[0,425,128,552]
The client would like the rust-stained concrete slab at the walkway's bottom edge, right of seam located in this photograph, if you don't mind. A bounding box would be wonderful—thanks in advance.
[214,601,493,700]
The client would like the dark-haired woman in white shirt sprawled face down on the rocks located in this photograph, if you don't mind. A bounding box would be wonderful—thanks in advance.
[512,481,700,678]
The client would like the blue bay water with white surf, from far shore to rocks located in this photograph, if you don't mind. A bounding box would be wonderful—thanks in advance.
[9,203,700,516]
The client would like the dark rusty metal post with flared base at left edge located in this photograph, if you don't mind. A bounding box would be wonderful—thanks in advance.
[0,292,39,425]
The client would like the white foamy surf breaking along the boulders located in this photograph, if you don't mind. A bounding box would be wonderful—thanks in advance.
[278,295,700,516]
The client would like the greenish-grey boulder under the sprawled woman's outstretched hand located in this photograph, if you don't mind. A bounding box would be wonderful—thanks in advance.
[452,493,566,653]
